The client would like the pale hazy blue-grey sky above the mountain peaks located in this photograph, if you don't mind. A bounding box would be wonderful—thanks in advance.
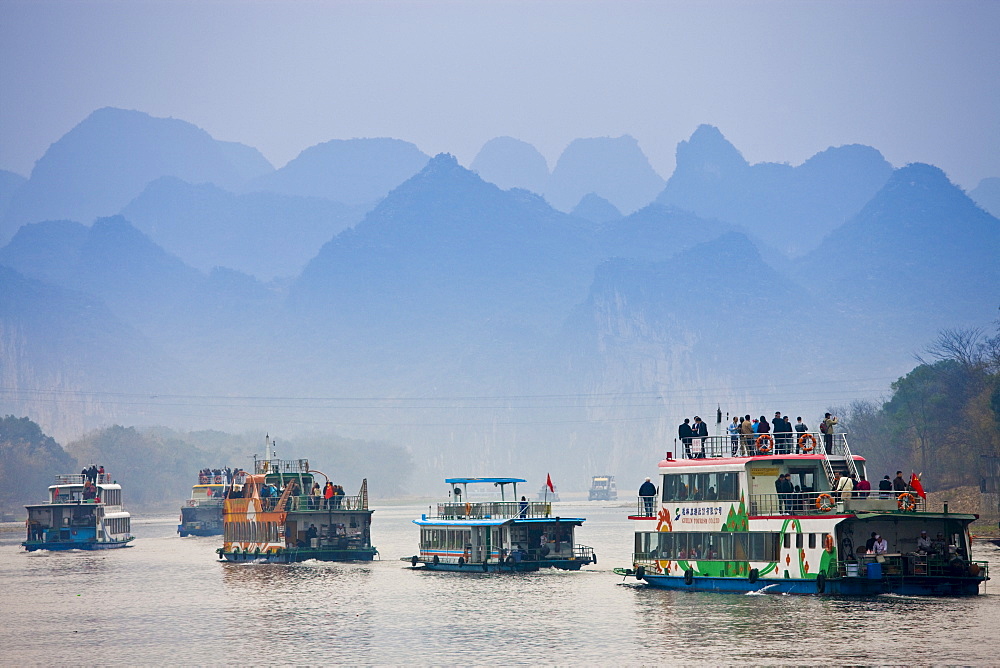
[0,0,1000,189]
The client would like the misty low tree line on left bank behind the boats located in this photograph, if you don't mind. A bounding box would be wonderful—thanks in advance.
[0,422,413,516]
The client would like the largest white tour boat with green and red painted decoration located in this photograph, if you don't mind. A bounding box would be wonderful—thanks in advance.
[615,433,989,596]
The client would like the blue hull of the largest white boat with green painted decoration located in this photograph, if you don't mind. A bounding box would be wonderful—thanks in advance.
[643,575,983,596]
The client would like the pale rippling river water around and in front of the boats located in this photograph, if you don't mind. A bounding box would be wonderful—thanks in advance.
[0,502,1000,666]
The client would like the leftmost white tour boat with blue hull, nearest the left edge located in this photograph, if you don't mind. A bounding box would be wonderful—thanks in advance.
[21,472,135,552]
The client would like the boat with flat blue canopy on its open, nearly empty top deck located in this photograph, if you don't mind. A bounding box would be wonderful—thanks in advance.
[401,478,597,573]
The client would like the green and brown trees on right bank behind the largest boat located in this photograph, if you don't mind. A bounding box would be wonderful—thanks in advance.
[841,321,1000,489]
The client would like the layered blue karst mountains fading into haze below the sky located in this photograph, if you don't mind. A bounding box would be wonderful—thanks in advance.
[0,109,1000,489]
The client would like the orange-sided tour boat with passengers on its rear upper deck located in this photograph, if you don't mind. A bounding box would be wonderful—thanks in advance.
[216,459,378,564]
